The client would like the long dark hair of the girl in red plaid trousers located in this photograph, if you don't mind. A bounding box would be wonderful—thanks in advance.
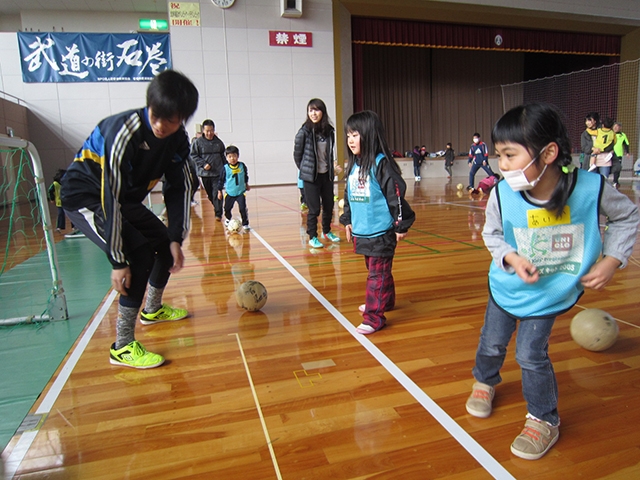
[344,110,402,181]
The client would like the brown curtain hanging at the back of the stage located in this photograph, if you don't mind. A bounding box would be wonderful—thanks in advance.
[353,45,524,154]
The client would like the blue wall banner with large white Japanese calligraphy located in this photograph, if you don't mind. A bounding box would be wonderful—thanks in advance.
[18,32,171,83]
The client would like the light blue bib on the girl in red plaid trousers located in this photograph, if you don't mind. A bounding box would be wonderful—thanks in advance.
[347,153,393,238]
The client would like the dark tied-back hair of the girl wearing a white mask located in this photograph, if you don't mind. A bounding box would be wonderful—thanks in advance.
[491,103,571,217]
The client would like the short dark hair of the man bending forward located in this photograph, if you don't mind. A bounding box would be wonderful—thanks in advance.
[147,70,198,122]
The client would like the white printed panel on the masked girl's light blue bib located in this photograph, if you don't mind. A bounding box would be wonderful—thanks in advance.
[513,223,584,276]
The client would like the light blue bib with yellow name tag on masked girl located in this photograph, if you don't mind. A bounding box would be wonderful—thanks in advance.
[489,170,603,318]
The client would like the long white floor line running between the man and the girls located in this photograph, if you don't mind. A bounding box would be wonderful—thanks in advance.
[251,229,515,479]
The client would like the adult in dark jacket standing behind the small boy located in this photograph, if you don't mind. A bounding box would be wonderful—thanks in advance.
[191,119,227,221]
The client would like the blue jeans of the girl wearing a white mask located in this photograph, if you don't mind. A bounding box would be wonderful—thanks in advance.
[473,297,560,425]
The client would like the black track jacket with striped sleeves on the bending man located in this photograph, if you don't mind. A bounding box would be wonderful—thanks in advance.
[61,108,191,268]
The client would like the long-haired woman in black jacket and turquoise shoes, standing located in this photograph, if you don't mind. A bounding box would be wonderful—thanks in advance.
[293,98,340,248]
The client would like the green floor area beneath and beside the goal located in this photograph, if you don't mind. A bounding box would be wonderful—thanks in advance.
[0,238,111,450]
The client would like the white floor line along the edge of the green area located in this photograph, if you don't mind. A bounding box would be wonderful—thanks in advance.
[4,290,118,480]
